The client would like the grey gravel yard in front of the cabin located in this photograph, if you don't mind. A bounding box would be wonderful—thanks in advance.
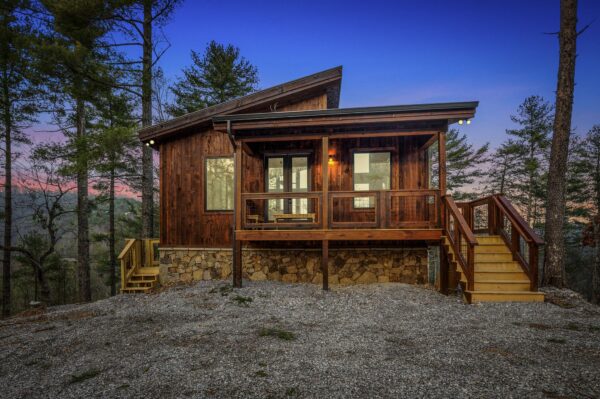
[0,282,600,398]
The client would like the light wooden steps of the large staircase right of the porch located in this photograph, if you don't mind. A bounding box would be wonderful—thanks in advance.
[444,235,544,303]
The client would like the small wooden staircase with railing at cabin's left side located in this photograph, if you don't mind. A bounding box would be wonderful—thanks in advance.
[119,239,159,294]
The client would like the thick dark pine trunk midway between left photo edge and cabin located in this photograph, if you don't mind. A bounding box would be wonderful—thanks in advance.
[76,98,92,302]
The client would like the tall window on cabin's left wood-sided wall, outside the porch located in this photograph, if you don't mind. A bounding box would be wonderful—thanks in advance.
[205,157,233,211]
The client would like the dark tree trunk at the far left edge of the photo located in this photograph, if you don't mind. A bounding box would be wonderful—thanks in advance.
[2,97,12,317]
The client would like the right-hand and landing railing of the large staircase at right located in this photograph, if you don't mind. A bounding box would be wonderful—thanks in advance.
[460,195,544,291]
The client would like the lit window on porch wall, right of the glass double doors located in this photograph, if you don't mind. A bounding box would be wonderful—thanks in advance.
[354,152,391,208]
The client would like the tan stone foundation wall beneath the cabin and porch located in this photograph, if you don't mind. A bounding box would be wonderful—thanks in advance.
[159,248,428,285]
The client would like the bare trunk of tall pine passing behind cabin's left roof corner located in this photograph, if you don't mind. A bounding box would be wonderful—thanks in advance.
[142,0,154,238]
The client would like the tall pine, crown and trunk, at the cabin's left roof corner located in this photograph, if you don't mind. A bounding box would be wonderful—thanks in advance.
[113,0,181,238]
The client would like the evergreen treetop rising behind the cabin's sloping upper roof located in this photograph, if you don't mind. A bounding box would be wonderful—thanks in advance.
[167,41,258,116]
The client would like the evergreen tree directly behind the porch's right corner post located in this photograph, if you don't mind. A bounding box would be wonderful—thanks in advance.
[446,129,489,198]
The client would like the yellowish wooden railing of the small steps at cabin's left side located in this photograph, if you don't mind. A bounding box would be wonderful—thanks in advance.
[118,238,159,292]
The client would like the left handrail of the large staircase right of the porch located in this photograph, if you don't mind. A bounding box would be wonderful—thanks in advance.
[443,195,477,291]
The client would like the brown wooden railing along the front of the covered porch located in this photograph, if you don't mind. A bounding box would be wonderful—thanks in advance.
[242,190,441,229]
